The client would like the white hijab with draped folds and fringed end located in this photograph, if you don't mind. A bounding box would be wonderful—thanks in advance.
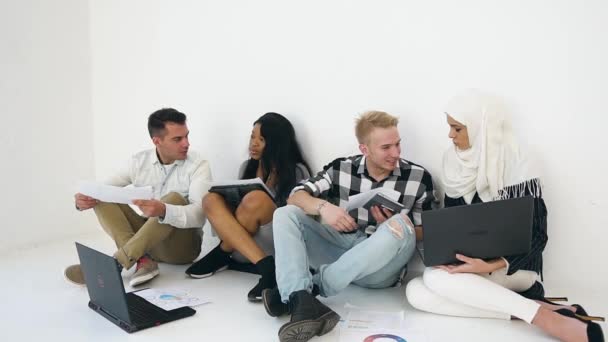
[442,90,540,204]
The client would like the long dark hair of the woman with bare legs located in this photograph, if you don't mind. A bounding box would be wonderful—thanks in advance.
[243,113,310,206]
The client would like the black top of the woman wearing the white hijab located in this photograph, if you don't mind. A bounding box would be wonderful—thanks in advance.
[444,188,548,298]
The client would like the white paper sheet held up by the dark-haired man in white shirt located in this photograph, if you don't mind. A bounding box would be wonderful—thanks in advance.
[78,182,154,204]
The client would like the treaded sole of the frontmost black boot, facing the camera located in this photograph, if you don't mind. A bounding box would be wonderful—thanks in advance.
[279,311,340,342]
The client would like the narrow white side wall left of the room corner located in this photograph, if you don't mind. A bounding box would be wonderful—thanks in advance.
[0,0,95,252]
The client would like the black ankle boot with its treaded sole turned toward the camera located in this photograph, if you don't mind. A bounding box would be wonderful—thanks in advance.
[279,290,340,342]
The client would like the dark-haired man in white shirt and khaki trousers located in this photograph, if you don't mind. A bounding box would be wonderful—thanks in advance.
[65,108,211,286]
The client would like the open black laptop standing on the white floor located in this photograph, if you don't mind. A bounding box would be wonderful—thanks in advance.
[76,242,196,333]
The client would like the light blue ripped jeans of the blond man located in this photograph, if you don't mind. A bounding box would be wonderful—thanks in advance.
[273,205,416,303]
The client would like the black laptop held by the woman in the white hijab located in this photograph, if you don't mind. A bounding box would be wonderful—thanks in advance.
[419,197,534,266]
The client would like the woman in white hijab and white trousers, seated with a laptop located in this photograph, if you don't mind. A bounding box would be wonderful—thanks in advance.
[406,91,604,342]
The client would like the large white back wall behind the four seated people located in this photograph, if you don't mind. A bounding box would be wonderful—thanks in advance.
[90,0,608,292]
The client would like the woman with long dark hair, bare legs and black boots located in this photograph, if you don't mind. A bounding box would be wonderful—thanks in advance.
[186,113,310,302]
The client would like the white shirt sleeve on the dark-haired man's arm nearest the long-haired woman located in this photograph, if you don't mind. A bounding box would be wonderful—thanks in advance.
[159,160,212,228]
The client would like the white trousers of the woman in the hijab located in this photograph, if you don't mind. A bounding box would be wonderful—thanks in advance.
[405,268,540,324]
